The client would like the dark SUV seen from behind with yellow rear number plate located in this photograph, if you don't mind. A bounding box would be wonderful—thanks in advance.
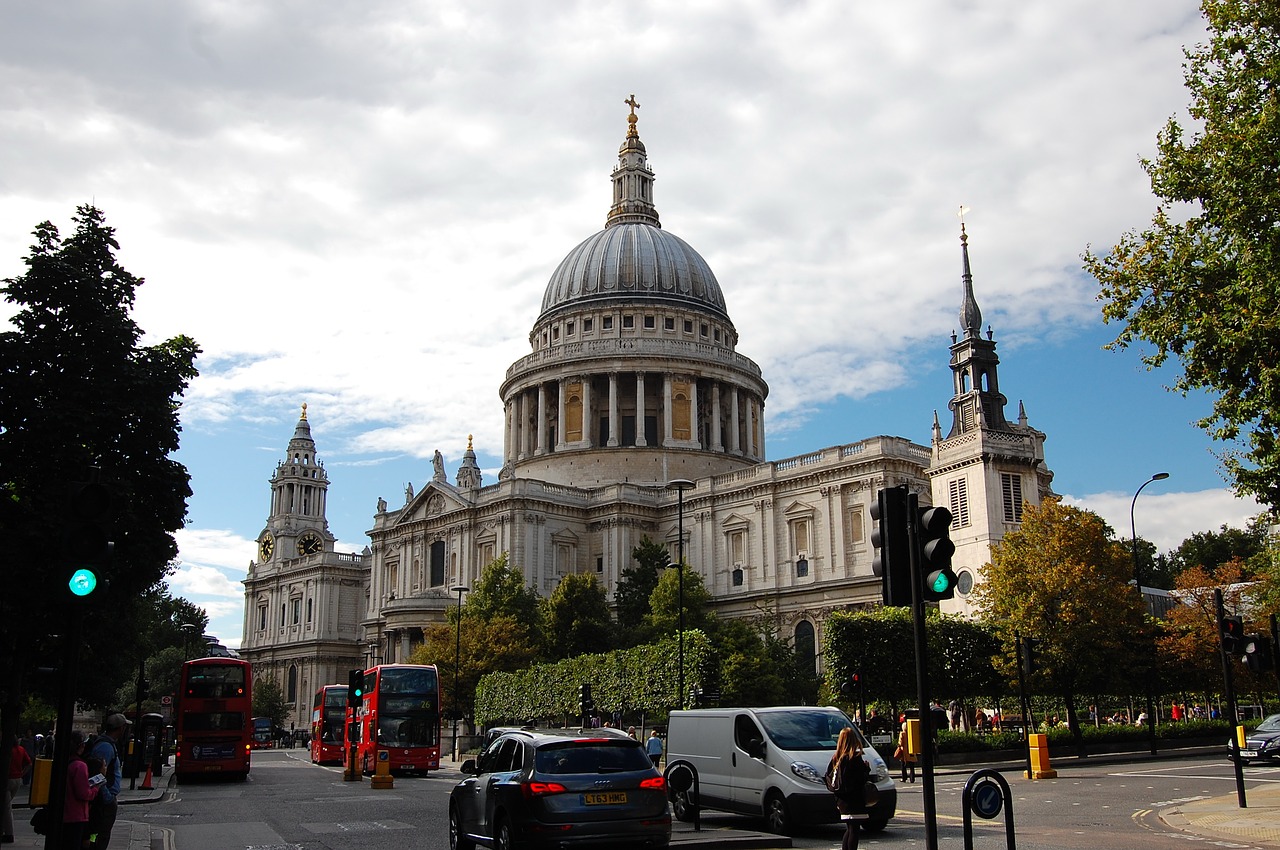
[449,730,671,850]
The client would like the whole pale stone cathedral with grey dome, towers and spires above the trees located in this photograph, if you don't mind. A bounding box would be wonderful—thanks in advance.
[241,99,1052,727]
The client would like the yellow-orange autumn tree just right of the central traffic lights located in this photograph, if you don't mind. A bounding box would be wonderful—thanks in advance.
[974,499,1153,744]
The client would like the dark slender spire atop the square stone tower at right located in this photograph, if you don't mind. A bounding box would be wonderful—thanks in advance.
[947,221,1010,439]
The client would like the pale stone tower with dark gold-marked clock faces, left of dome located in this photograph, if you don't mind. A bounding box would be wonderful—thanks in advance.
[241,405,370,731]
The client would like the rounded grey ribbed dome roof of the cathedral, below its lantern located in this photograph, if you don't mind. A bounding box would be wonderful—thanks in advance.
[541,221,728,319]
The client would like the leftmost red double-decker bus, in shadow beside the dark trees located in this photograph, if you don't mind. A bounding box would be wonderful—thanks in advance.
[173,658,253,778]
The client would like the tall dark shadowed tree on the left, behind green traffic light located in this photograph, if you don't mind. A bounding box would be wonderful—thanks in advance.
[0,205,200,732]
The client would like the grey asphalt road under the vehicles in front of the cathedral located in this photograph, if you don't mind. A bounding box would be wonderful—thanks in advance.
[142,750,1280,850]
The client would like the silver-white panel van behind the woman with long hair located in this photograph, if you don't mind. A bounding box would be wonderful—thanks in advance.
[667,705,897,833]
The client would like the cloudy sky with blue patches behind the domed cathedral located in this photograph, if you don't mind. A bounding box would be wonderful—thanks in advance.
[0,0,1258,646]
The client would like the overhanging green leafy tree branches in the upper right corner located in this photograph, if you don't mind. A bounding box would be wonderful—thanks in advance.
[1083,0,1280,504]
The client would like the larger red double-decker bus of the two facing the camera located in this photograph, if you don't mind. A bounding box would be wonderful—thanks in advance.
[356,664,440,773]
